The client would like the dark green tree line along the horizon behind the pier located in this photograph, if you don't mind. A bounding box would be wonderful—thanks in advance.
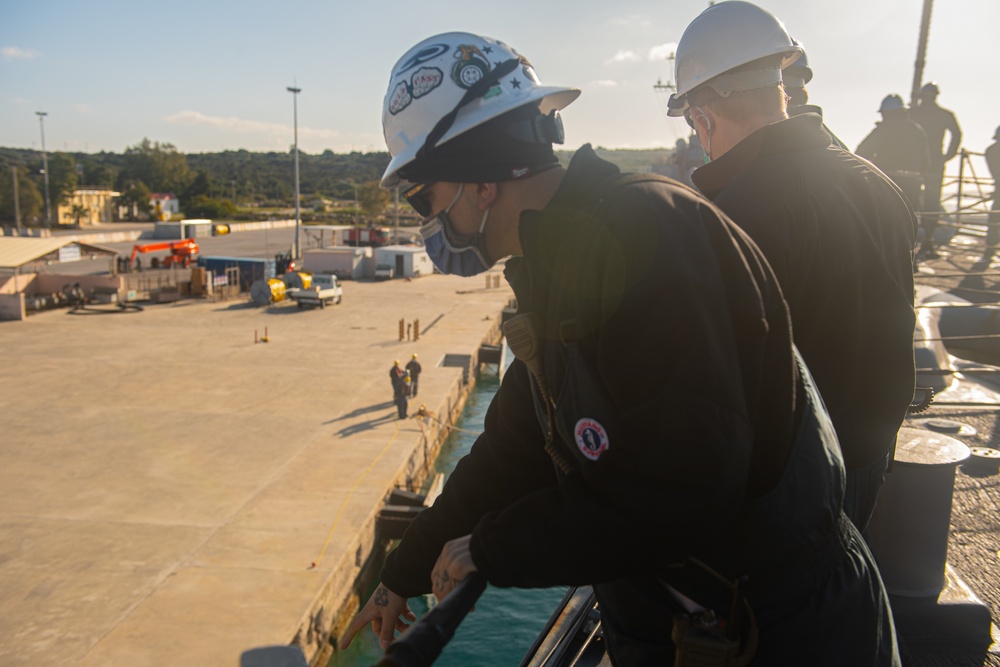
[0,139,670,226]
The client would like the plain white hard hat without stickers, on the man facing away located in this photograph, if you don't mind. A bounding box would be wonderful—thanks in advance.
[667,0,802,116]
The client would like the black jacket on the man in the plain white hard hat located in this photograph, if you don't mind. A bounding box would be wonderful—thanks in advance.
[694,114,916,470]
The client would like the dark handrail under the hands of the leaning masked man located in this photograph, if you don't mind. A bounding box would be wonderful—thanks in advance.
[376,572,486,667]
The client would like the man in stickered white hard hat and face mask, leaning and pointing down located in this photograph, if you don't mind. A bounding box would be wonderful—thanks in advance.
[341,33,895,665]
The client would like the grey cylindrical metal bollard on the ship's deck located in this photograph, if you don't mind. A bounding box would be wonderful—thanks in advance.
[867,428,971,598]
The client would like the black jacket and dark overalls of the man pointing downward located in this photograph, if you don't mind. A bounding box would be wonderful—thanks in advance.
[382,147,892,664]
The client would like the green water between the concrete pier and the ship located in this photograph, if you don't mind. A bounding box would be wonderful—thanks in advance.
[330,368,566,667]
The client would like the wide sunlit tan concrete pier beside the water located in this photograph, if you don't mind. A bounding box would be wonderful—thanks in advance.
[0,268,512,667]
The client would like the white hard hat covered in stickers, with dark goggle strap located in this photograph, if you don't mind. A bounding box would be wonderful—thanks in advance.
[381,32,580,188]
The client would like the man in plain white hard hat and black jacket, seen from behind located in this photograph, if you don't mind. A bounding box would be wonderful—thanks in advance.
[669,1,916,544]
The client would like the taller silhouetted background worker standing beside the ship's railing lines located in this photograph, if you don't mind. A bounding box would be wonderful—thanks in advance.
[910,83,962,259]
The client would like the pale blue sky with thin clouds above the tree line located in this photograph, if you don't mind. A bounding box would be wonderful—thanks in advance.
[0,0,1000,159]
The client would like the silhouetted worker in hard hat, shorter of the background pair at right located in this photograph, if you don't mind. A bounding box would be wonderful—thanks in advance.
[854,94,930,217]
